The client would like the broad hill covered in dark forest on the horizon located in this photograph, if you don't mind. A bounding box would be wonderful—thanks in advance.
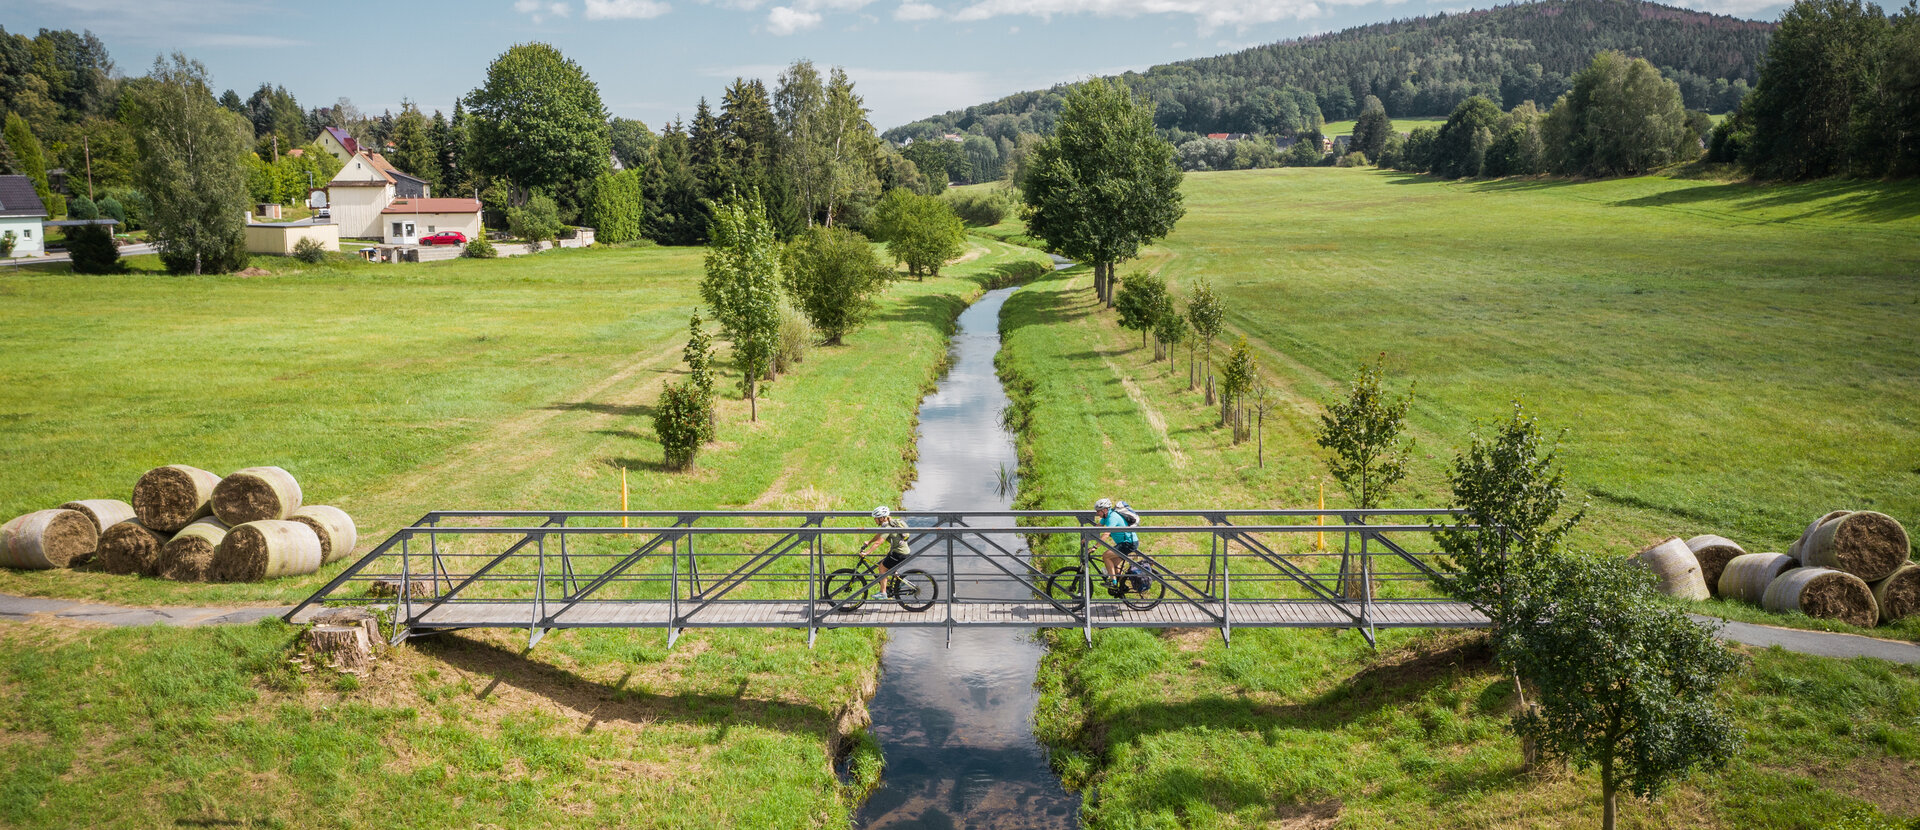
[887,0,1774,142]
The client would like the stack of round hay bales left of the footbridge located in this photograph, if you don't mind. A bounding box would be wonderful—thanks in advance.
[0,465,359,582]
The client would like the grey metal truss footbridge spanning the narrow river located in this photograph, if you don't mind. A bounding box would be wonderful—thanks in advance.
[288,509,1484,644]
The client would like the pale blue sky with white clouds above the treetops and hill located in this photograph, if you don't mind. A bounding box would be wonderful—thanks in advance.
[0,0,1786,131]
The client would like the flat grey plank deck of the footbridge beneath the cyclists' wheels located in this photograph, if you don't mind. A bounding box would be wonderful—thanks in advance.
[403,599,1488,628]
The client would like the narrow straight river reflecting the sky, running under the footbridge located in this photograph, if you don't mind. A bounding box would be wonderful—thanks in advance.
[858,288,1079,830]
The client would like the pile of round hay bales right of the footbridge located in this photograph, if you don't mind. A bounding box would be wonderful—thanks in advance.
[1636,511,1920,628]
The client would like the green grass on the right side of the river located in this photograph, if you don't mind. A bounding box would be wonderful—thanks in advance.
[996,169,1920,826]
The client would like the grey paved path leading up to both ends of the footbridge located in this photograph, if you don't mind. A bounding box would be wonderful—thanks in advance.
[0,594,1920,665]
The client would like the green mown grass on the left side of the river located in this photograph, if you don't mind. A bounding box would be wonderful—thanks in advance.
[0,240,1035,826]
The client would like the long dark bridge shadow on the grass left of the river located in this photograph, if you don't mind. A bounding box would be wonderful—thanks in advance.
[415,634,833,738]
